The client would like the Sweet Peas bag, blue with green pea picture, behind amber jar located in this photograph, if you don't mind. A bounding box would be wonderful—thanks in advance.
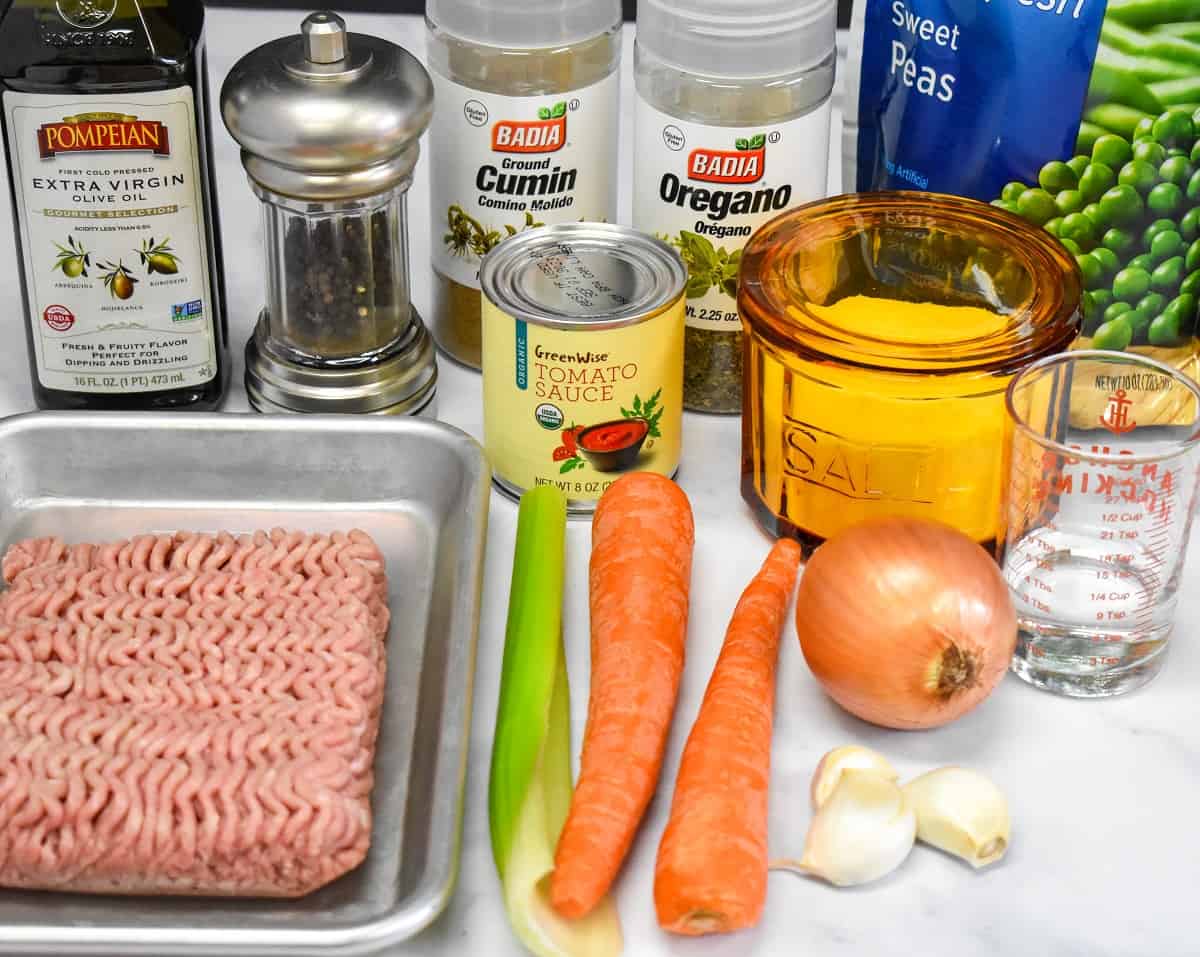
[844,0,1200,421]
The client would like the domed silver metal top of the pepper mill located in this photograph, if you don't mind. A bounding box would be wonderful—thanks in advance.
[221,11,433,200]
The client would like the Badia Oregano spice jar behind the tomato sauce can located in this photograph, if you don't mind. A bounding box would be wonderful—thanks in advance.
[634,0,836,413]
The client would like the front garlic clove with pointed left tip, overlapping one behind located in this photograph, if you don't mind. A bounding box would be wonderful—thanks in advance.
[799,768,917,887]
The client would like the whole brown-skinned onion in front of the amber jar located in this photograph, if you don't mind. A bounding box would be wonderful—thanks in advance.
[796,518,1016,729]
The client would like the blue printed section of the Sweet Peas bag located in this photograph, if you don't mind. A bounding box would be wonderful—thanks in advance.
[844,0,1104,200]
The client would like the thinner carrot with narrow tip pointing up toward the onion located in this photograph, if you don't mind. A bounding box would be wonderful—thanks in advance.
[654,540,800,935]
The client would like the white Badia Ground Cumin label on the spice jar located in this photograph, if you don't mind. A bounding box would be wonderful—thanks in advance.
[430,71,619,289]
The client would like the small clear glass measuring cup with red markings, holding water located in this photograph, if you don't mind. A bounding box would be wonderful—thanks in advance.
[1002,350,1200,698]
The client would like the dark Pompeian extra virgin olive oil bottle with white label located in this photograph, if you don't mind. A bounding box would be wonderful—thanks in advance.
[0,0,229,410]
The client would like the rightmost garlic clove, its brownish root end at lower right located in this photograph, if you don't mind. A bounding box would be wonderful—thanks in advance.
[904,768,1009,867]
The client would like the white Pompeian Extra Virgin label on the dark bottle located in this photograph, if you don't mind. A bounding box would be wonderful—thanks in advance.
[4,86,217,393]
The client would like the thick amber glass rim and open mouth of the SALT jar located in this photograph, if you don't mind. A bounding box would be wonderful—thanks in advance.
[738,191,1082,373]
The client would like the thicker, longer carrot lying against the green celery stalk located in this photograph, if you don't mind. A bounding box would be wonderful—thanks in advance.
[550,473,695,919]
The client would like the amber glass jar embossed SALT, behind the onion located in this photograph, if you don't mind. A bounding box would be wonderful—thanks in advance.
[738,192,1081,547]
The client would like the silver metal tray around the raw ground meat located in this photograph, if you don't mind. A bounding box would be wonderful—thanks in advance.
[0,413,491,957]
